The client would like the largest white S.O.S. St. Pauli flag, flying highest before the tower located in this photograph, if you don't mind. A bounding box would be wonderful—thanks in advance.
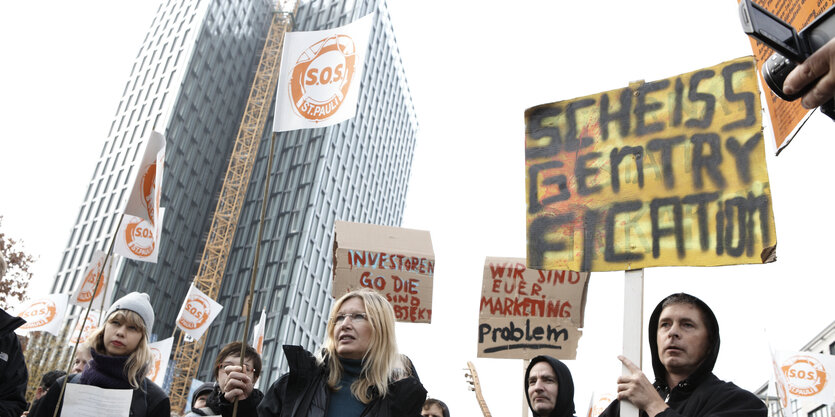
[273,14,374,132]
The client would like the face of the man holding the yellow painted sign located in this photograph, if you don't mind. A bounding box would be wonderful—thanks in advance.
[656,303,708,378]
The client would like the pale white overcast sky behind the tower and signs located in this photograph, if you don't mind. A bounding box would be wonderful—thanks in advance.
[0,0,835,416]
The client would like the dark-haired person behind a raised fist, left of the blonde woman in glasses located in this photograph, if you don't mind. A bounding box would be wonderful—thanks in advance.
[187,342,264,417]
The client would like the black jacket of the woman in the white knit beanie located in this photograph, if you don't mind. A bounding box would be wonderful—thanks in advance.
[29,374,171,417]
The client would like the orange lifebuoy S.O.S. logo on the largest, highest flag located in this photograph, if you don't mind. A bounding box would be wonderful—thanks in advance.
[290,35,357,121]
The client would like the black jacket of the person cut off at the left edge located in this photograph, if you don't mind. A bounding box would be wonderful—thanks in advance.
[0,309,29,417]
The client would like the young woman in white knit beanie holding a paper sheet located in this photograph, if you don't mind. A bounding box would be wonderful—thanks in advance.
[30,292,171,417]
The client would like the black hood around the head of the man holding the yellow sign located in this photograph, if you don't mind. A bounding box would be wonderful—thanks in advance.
[648,293,719,389]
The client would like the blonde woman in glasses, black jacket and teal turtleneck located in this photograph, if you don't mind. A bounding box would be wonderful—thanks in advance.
[258,289,426,417]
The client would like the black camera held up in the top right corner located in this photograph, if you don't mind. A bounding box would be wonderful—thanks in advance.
[739,0,835,120]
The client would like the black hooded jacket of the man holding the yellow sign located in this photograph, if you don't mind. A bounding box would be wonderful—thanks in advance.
[600,294,768,417]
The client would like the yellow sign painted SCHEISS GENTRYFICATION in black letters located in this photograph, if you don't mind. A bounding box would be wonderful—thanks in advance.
[525,57,777,271]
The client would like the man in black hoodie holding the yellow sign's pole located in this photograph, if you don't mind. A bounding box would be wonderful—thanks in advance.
[601,293,767,417]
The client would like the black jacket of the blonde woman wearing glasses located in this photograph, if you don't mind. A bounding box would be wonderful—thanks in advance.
[258,345,426,417]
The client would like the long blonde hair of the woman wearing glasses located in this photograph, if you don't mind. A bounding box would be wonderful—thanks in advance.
[317,288,412,404]
